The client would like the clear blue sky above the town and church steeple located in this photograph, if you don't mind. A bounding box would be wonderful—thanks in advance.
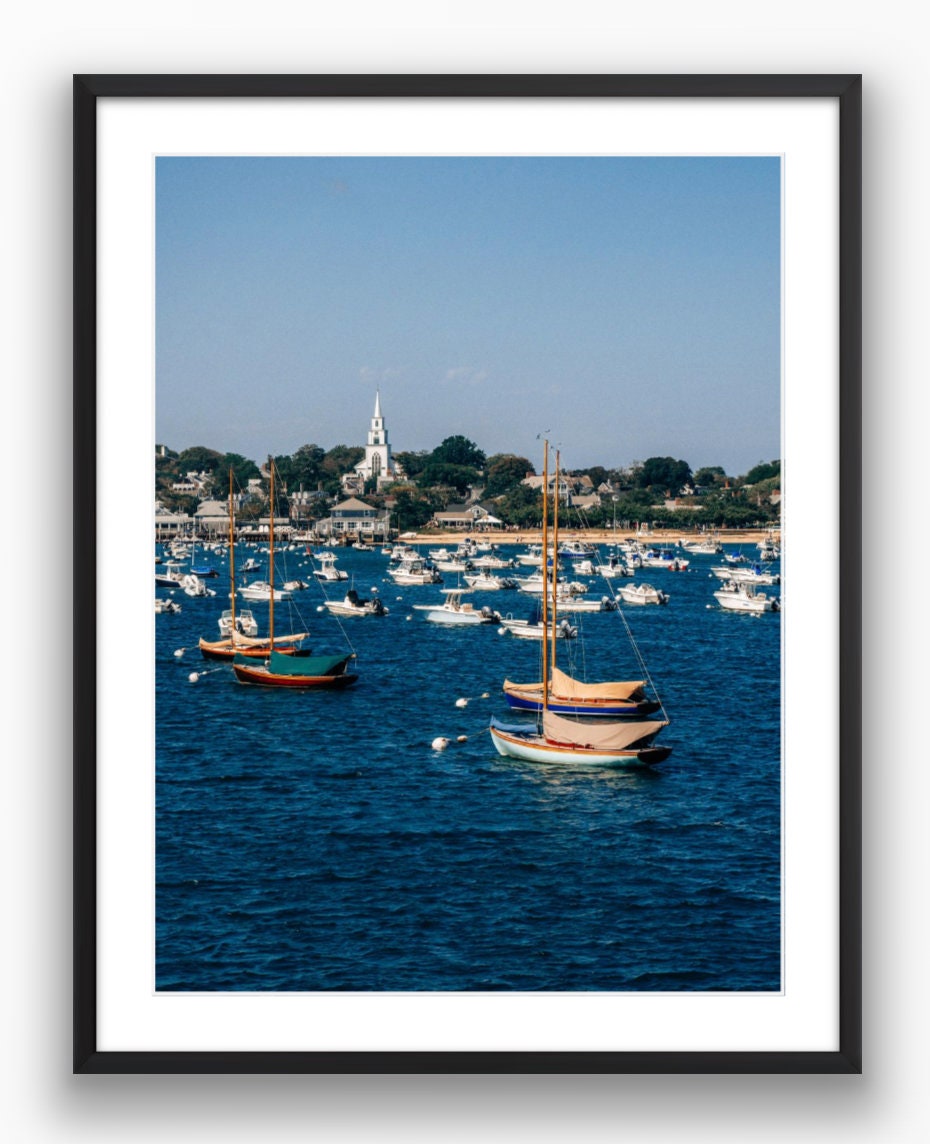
[156,157,780,475]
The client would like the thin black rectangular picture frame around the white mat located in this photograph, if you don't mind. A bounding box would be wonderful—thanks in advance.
[73,74,861,1074]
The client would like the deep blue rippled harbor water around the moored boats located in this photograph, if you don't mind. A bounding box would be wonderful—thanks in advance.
[154,547,781,992]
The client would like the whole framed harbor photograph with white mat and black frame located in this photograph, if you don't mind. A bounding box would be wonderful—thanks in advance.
[73,74,861,1073]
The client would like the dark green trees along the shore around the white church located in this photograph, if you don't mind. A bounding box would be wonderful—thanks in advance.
[156,435,781,531]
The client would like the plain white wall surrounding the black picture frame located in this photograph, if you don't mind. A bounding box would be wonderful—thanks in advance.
[0,0,930,1144]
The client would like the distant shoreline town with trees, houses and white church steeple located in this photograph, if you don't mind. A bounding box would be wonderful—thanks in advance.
[154,394,781,541]
